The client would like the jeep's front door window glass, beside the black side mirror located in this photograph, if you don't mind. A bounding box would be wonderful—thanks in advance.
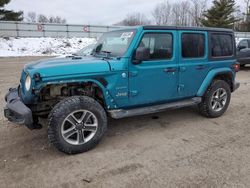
[139,33,173,60]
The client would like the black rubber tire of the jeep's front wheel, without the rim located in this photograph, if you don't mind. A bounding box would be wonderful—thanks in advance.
[48,96,107,154]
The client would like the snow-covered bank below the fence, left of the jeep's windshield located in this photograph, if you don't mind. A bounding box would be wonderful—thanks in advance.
[0,37,96,57]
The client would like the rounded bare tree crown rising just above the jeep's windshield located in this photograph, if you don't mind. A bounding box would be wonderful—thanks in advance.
[115,12,150,26]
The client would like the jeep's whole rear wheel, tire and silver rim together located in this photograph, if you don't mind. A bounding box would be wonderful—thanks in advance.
[199,80,231,118]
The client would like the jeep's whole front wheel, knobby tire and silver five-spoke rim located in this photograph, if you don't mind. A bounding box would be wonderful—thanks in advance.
[48,96,107,154]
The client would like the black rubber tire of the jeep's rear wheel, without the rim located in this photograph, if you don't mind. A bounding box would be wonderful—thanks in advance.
[198,80,231,118]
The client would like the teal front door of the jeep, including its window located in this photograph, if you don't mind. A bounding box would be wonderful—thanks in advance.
[129,30,178,106]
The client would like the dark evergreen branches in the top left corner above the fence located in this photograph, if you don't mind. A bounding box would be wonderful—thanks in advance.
[0,0,23,21]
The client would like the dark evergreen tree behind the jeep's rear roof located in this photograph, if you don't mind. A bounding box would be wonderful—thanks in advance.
[201,0,238,28]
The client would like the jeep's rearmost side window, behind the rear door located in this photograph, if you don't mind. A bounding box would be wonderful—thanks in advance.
[211,33,234,57]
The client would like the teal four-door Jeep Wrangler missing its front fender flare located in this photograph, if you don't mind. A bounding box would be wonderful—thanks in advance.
[4,26,239,154]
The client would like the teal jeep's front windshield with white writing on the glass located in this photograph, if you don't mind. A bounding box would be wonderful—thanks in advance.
[94,29,135,57]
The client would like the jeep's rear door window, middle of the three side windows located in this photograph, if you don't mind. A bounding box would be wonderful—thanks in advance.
[181,33,205,58]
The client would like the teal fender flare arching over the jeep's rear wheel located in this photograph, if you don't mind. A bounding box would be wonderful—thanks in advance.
[196,68,233,97]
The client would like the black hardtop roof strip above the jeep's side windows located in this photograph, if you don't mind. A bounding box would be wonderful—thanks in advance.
[142,25,234,32]
